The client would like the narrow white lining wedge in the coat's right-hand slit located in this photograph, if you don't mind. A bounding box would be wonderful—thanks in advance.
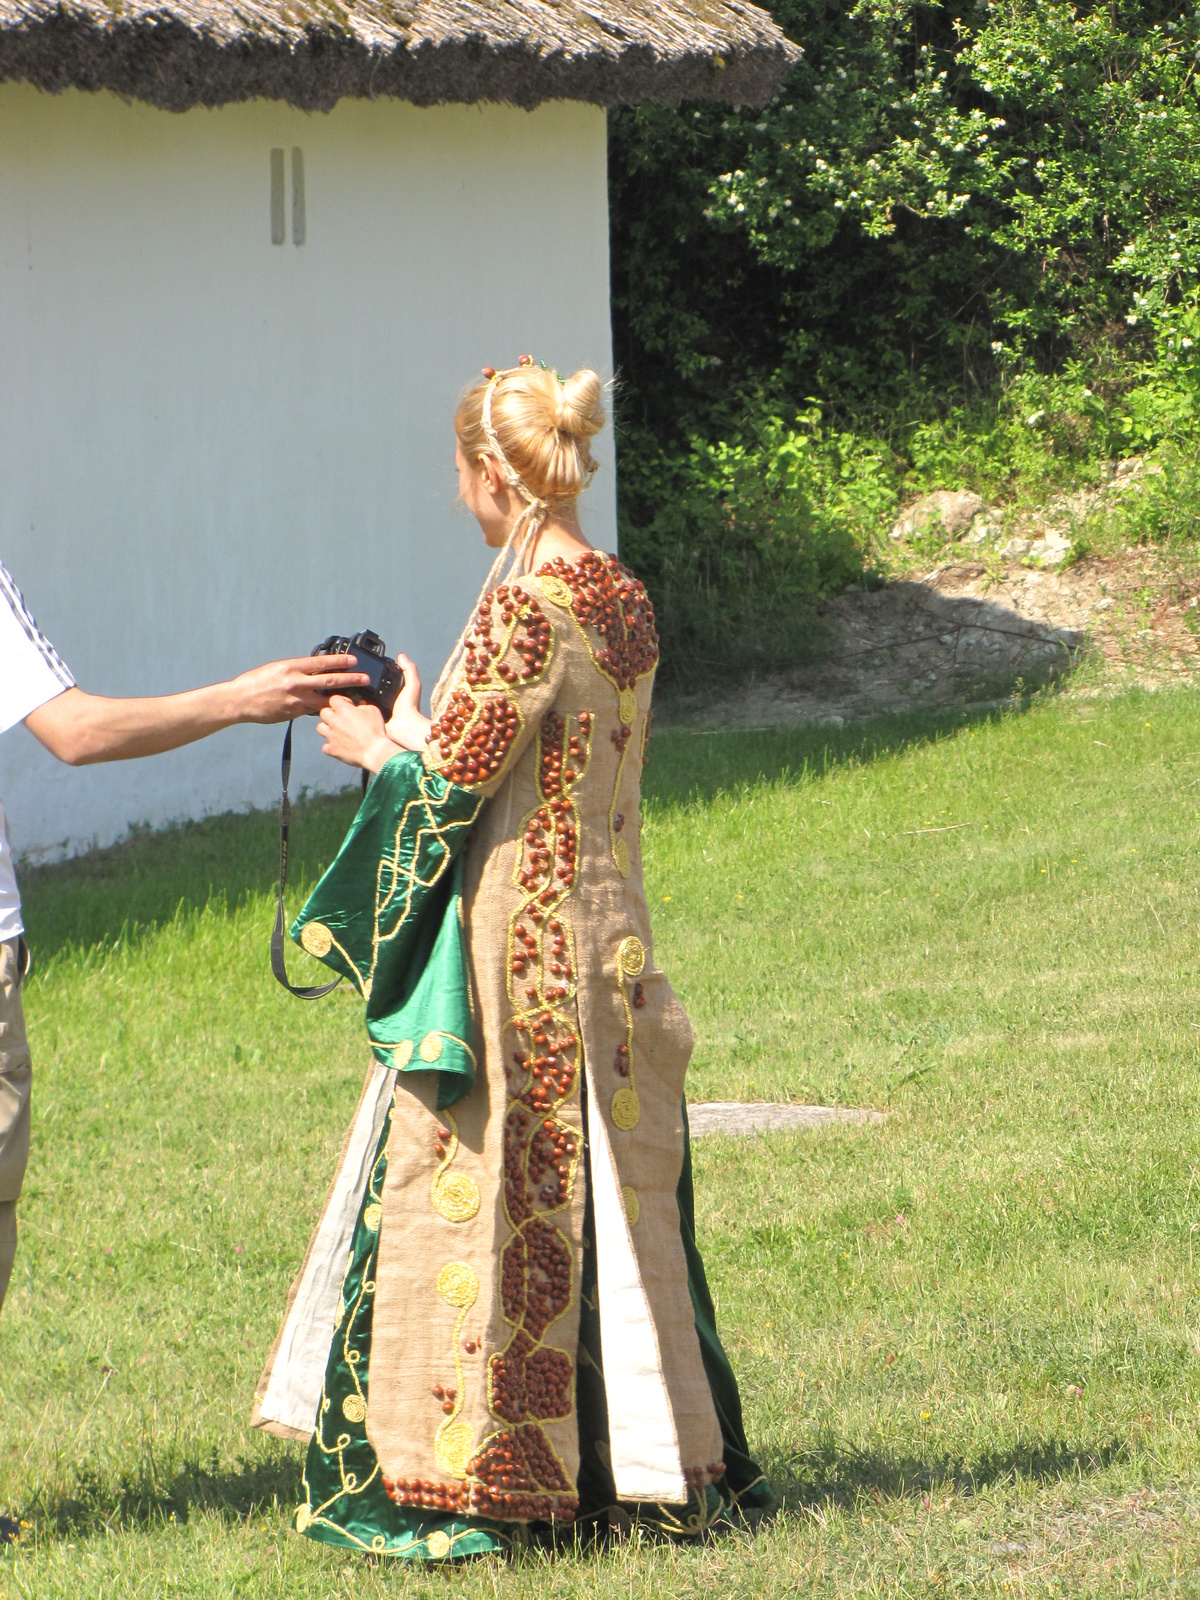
[587,1066,688,1506]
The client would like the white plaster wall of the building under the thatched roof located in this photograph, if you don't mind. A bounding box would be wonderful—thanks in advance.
[0,85,616,856]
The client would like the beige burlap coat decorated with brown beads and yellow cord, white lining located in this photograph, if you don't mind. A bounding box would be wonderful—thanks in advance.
[256,552,722,1520]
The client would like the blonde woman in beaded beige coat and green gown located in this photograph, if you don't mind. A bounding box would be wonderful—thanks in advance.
[254,357,776,1560]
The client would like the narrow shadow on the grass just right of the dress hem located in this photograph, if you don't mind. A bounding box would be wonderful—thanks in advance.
[765,1438,1130,1510]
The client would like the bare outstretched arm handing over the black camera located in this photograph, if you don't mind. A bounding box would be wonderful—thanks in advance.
[24,656,368,766]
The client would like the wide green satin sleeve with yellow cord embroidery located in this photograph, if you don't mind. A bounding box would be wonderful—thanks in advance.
[291,750,485,1107]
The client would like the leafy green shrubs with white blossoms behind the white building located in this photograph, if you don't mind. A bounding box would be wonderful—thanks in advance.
[610,0,1200,675]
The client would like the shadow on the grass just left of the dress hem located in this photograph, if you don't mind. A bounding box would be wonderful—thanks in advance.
[21,1454,304,1538]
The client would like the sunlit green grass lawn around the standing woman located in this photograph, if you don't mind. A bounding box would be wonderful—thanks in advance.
[0,693,1200,1600]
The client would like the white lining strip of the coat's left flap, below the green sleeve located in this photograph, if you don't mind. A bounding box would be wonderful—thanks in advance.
[261,1061,395,1429]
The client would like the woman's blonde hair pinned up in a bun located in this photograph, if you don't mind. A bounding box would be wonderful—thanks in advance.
[454,365,605,506]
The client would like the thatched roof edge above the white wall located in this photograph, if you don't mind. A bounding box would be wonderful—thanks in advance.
[0,0,800,110]
